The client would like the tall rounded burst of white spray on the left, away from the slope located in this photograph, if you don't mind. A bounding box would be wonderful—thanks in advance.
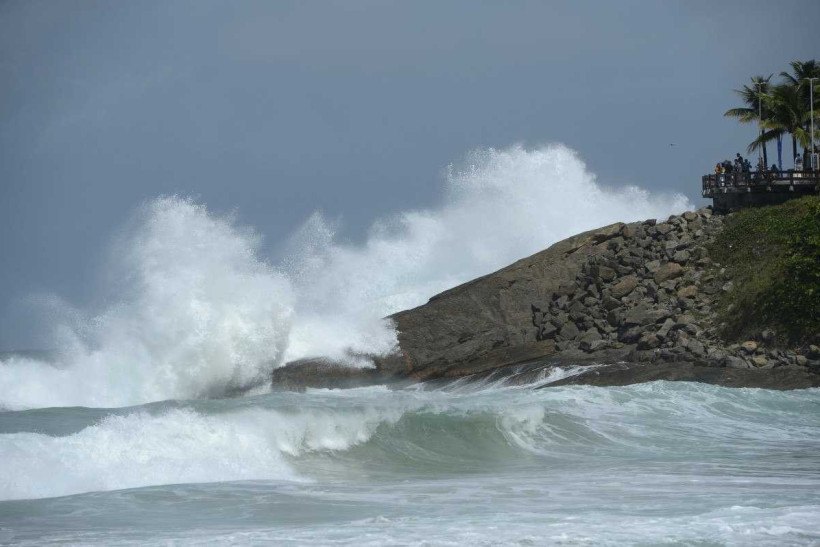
[0,197,292,409]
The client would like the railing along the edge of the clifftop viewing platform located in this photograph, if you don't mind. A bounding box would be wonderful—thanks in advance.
[702,171,820,198]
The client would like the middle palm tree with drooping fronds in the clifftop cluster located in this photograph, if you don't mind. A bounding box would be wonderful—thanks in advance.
[749,83,811,167]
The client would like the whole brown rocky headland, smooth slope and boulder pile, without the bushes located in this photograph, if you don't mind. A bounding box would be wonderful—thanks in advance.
[273,199,820,389]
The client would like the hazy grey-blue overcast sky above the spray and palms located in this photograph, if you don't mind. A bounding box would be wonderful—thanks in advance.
[0,0,820,349]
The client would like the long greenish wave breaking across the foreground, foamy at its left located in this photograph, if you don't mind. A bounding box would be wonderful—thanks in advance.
[0,382,818,500]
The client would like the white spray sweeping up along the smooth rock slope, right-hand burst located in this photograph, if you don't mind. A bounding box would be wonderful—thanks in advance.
[278,145,691,359]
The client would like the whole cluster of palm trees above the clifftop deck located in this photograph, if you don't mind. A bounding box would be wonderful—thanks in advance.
[724,59,820,169]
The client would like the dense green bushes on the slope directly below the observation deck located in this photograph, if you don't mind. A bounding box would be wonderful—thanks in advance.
[709,196,820,345]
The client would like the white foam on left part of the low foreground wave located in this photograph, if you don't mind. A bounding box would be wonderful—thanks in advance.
[0,408,401,499]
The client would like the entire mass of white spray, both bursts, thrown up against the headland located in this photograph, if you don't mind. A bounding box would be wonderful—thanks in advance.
[0,145,690,408]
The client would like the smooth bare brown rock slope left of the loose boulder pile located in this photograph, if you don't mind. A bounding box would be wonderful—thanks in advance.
[391,222,624,379]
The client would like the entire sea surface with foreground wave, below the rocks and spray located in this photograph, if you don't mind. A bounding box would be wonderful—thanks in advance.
[0,368,820,545]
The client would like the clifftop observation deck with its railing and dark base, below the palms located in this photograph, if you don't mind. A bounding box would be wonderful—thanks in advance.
[702,171,820,212]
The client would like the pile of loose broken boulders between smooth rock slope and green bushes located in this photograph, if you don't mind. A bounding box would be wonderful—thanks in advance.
[531,208,820,368]
